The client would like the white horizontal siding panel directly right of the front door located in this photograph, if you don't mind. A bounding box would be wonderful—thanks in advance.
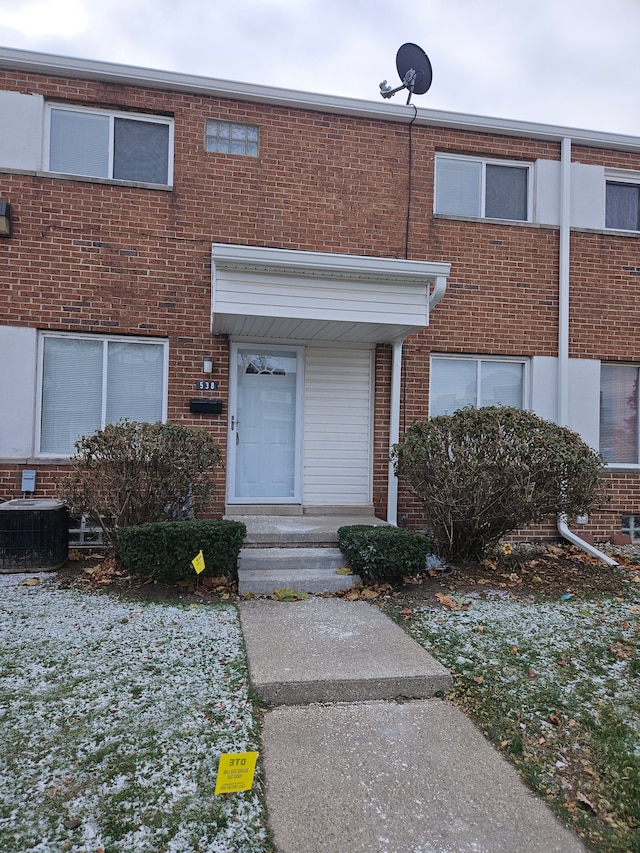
[303,347,373,506]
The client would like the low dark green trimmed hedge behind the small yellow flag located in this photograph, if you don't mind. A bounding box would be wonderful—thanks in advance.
[119,519,247,582]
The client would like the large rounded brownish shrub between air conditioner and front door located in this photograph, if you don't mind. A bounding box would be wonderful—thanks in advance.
[58,421,220,554]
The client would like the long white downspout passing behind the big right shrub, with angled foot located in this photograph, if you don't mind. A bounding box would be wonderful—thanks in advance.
[557,137,618,566]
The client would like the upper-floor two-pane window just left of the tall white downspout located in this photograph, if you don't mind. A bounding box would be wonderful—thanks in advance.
[435,154,532,222]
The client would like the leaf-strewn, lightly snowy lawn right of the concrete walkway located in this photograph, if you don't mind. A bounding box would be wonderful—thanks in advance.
[407,592,640,853]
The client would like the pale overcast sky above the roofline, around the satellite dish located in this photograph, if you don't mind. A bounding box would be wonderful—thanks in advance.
[0,0,640,135]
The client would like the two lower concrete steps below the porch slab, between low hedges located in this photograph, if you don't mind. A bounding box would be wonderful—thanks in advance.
[238,548,358,595]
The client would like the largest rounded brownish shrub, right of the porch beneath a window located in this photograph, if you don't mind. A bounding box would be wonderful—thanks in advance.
[391,406,605,559]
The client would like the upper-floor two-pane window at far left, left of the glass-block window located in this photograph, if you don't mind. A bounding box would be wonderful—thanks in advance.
[47,105,173,186]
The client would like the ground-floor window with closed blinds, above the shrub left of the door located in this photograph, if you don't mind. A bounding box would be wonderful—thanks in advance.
[38,332,168,456]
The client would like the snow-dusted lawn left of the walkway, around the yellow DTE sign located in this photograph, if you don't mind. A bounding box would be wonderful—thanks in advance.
[0,575,269,853]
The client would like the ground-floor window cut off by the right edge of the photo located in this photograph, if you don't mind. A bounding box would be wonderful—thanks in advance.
[600,364,640,465]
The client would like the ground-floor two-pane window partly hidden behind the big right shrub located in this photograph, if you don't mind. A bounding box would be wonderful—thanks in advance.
[429,355,527,418]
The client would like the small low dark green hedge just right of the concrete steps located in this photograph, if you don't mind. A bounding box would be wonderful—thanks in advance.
[338,524,431,583]
